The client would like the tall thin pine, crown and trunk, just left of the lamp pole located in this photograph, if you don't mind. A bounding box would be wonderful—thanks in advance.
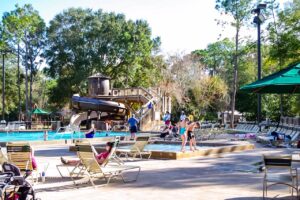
[216,0,252,128]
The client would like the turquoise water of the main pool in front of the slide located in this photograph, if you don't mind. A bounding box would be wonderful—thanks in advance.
[0,131,128,142]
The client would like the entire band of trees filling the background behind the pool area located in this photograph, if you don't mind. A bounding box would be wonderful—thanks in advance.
[0,0,300,120]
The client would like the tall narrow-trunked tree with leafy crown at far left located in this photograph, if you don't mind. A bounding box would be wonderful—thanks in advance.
[2,4,46,120]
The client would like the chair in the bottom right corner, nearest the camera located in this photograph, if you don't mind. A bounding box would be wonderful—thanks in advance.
[263,155,298,199]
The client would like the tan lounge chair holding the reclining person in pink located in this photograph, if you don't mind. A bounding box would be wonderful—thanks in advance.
[71,141,141,186]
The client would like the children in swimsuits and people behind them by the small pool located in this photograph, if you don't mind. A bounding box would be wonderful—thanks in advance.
[161,111,201,152]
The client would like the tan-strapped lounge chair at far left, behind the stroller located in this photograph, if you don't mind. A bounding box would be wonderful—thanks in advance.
[6,142,39,182]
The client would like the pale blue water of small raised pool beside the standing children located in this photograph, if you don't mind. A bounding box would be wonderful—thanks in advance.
[120,144,209,152]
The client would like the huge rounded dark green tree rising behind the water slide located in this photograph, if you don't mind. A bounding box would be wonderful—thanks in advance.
[46,8,160,105]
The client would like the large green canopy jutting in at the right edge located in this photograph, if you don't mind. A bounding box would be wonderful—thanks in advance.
[240,62,300,94]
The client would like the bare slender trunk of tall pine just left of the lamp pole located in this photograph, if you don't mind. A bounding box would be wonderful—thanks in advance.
[230,26,239,128]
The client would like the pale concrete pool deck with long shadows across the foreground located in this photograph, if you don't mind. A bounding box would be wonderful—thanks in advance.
[18,142,300,200]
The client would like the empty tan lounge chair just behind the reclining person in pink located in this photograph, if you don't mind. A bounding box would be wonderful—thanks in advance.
[117,136,151,159]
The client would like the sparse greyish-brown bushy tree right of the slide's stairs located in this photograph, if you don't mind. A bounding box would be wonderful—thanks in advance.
[160,53,227,120]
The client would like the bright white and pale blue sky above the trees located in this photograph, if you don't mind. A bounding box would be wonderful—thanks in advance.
[0,0,285,54]
